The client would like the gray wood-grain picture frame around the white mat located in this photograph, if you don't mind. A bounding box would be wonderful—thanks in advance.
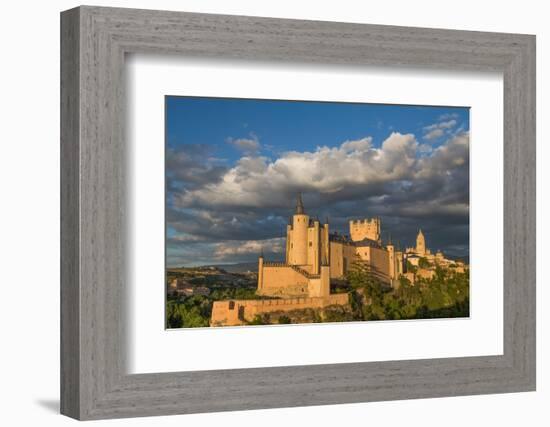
[61,6,535,420]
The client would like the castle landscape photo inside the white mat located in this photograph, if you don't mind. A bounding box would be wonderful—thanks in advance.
[165,96,469,328]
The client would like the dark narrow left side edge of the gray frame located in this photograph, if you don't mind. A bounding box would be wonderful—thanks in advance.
[60,10,80,417]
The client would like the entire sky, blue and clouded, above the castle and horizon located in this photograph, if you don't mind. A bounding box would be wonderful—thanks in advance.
[165,96,469,265]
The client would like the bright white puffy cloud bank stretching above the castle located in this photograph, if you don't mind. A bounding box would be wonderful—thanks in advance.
[175,132,418,207]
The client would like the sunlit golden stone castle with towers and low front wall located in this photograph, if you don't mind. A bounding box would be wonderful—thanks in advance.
[211,194,458,326]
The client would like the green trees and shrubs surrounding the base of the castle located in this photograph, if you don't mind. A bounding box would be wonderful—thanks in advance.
[166,258,470,328]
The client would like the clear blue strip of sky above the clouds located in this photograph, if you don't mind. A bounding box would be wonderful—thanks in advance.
[166,96,469,161]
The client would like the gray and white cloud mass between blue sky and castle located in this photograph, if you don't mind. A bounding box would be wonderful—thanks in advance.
[167,131,469,263]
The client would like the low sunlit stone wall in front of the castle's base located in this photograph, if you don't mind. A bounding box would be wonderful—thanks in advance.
[210,294,349,326]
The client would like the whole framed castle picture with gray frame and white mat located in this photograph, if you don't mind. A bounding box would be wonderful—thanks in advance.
[61,6,535,419]
